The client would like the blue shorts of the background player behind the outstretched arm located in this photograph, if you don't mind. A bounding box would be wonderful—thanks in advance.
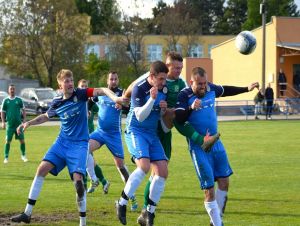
[90,129,124,159]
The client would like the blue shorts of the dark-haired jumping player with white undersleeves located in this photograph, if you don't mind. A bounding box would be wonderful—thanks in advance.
[125,131,168,162]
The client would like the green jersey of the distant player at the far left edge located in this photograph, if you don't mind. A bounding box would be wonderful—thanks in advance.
[1,97,24,127]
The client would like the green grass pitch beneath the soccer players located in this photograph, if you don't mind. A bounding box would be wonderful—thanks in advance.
[0,121,300,226]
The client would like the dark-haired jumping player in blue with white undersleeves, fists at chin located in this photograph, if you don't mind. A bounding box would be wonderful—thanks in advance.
[116,61,168,225]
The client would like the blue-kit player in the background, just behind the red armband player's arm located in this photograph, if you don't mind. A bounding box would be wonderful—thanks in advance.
[87,71,138,211]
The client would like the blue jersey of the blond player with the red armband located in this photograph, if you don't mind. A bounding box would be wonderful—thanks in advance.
[47,89,89,141]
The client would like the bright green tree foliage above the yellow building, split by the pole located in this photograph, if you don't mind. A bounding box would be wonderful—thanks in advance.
[243,0,300,30]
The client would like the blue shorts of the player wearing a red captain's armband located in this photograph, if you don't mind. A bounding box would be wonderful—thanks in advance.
[43,138,88,176]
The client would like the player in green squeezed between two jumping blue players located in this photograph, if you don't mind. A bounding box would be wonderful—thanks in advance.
[125,52,219,225]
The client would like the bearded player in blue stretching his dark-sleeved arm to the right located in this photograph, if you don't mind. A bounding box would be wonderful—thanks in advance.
[175,67,259,226]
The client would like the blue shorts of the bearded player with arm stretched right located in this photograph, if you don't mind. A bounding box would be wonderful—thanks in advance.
[189,140,233,189]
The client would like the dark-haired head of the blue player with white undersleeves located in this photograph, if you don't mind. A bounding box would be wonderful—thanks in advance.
[148,61,169,89]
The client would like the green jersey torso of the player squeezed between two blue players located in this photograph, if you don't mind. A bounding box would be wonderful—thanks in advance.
[167,78,186,108]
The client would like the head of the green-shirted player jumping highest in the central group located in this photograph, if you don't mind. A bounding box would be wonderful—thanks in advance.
[166,52,183,79]
